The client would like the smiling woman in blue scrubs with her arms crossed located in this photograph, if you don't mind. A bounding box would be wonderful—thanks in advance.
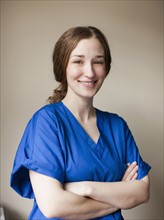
[11,27,150,220]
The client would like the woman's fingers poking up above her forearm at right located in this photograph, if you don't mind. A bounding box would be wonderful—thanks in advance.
[122,162,138,181]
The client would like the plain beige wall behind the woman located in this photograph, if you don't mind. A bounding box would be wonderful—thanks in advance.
[0,0,163,220]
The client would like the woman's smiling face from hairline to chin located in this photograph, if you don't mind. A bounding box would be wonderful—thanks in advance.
[66,37,106,98]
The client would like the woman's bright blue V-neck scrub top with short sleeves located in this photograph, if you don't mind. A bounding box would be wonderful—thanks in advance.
[11,102,151,220]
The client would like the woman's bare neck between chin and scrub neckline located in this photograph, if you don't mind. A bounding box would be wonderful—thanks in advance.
[62,96,95,122]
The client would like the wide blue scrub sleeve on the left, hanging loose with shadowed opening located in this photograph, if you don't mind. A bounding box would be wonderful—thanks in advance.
[10,109,64,198]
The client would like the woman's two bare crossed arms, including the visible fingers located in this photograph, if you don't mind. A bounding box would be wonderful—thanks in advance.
[29,162,149,219]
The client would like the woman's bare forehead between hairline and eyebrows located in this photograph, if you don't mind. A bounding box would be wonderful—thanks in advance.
[71,37,104,56]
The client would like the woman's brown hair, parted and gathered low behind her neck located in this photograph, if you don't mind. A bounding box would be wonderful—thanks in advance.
[48,26,111,103]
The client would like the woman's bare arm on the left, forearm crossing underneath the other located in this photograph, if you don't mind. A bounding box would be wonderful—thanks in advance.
[29,171,118,220]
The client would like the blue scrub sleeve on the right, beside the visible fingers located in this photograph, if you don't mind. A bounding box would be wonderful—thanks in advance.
[123,117,151,179]
